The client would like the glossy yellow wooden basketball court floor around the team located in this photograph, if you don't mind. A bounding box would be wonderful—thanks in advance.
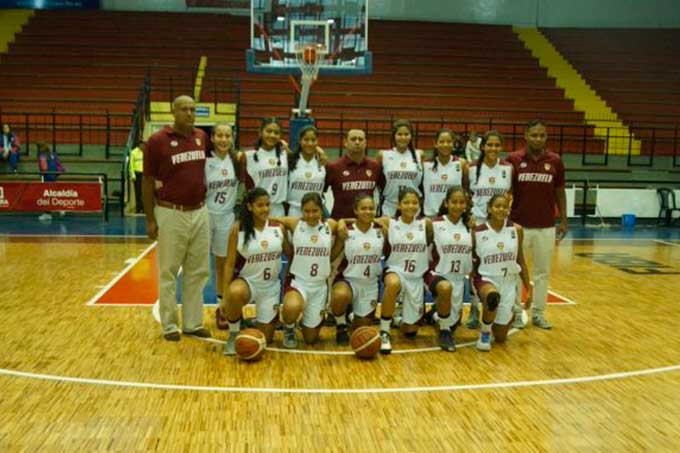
[0,230,680,451]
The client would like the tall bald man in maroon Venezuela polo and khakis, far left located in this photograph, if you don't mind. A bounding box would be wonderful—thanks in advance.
[142,96,210,341]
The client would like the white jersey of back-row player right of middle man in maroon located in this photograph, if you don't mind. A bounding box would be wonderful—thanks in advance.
[382,149,423,217]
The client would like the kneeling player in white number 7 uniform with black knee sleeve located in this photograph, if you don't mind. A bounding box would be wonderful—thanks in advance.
[472,195,532,351]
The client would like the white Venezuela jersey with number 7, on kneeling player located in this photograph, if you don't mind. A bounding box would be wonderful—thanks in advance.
[475,221,520,277]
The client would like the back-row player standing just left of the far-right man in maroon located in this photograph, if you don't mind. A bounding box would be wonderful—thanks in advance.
[467,131,510,329]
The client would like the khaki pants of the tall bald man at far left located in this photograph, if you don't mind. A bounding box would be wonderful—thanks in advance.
[155,206,210,333]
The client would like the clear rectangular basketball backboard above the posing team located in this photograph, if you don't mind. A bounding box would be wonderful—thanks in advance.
[246,0,372,75]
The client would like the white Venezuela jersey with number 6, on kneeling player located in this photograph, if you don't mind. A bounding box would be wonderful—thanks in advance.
[235,221,283,281]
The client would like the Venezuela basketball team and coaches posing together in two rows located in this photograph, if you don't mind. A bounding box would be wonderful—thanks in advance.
[142,96,567,355]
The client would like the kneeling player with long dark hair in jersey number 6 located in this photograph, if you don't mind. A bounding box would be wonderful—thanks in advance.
[224,187,288,355]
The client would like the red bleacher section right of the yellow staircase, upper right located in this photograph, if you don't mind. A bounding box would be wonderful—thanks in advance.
[542,28,680,154]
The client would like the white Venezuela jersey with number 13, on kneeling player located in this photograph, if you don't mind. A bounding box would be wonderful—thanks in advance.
[431,216,472,276]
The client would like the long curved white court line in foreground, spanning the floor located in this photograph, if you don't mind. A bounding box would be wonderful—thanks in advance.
[0,365,680,394]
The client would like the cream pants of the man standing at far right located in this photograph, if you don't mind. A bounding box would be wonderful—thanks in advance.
[522,227,555,316]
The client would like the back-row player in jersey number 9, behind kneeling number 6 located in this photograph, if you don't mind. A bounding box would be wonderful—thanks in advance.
[239,117,288,217]
